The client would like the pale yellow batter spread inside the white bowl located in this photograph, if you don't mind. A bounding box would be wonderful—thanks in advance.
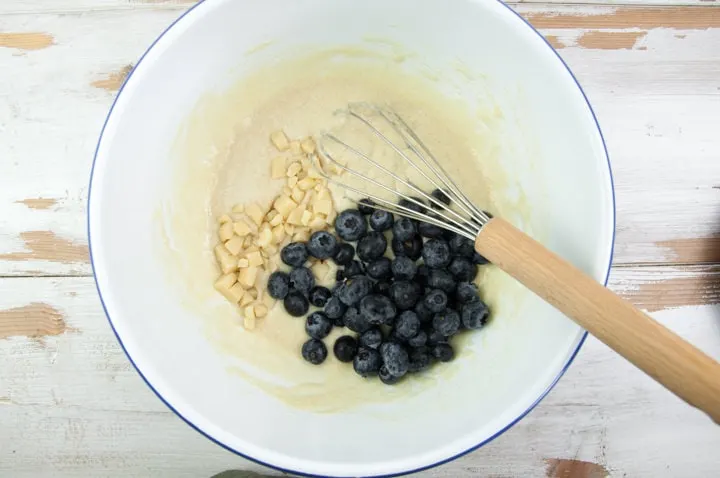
[161,51,519,412]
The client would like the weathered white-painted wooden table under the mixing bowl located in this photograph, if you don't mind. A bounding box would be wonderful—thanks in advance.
[0,0,720,478]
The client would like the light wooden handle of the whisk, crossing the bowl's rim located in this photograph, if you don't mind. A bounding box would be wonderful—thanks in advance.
[475,219,720,424]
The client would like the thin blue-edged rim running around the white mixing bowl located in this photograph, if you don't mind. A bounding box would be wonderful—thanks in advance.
[87,0,616,478]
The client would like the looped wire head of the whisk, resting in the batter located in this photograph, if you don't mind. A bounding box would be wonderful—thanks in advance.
[315,103,490,240]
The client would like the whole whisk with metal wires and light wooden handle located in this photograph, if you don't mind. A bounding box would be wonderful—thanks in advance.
[316,103,720,423]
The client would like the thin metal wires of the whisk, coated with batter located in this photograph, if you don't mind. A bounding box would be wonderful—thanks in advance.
[315,103,490,240]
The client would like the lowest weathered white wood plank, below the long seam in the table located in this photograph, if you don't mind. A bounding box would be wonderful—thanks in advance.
[0,267,720,477]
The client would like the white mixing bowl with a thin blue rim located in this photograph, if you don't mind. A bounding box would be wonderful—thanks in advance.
[88,0,614,476]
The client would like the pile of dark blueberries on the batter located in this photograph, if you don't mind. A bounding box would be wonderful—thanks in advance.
[268,190,489,384]
